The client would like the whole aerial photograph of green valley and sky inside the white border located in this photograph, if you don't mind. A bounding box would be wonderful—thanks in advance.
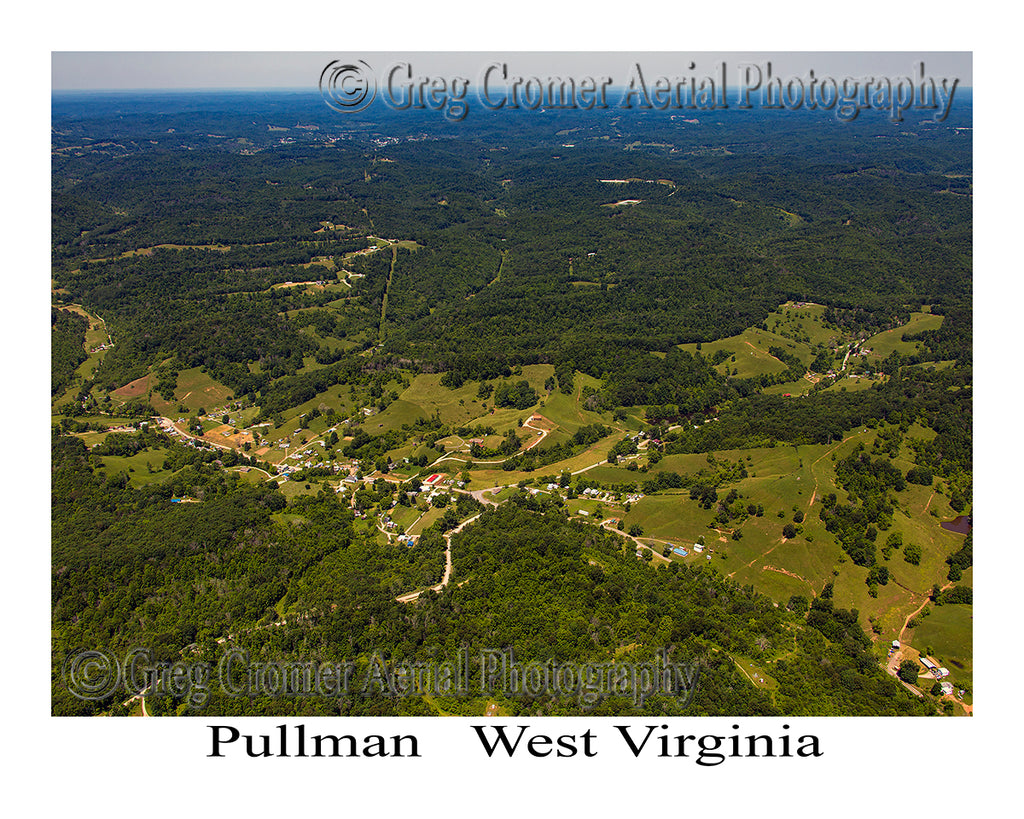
[51,51,974,724]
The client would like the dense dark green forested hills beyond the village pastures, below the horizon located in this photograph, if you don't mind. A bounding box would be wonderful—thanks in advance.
[53,96,971,403]
